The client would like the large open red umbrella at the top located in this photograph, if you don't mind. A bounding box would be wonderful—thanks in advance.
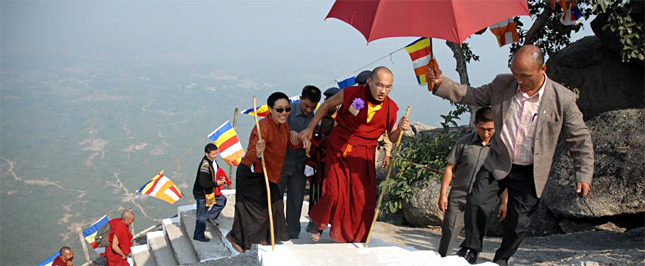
[327,0,530,43]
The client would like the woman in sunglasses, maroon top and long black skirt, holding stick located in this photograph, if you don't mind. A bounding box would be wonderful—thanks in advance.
[226,92,291,253]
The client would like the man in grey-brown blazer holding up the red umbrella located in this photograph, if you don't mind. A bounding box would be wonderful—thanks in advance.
[427,45,594,265]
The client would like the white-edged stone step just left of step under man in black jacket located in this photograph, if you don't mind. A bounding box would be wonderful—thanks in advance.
[163,218,198,265]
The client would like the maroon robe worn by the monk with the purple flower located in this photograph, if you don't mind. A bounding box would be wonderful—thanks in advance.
[309,86,399,242]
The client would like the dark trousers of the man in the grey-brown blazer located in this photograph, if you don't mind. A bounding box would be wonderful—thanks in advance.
[461,165,540,262]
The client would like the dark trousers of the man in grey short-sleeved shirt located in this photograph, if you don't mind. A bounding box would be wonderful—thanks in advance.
[437,198,464,257]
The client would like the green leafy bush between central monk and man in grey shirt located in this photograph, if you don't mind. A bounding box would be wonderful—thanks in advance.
[379,105,468,213]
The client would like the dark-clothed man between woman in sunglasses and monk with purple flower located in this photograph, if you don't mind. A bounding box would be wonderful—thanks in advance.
[276,85,321,239]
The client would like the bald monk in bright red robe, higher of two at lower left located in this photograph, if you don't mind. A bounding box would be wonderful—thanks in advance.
[105,210,134,266]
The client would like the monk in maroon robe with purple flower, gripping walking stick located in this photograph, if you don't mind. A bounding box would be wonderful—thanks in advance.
[300,66,410,242]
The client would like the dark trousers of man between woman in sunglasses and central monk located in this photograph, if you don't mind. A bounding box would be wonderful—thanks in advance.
[278,167,307,239]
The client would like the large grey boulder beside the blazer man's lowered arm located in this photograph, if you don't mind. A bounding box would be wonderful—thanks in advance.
[543,109,645,220]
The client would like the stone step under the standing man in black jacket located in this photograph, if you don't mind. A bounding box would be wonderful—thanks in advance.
[180,209,232,262]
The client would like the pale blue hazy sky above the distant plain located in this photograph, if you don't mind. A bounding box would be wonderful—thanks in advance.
[1,0,592,126]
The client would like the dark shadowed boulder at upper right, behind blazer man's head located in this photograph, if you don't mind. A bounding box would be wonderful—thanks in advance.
[547,36,645,120]
